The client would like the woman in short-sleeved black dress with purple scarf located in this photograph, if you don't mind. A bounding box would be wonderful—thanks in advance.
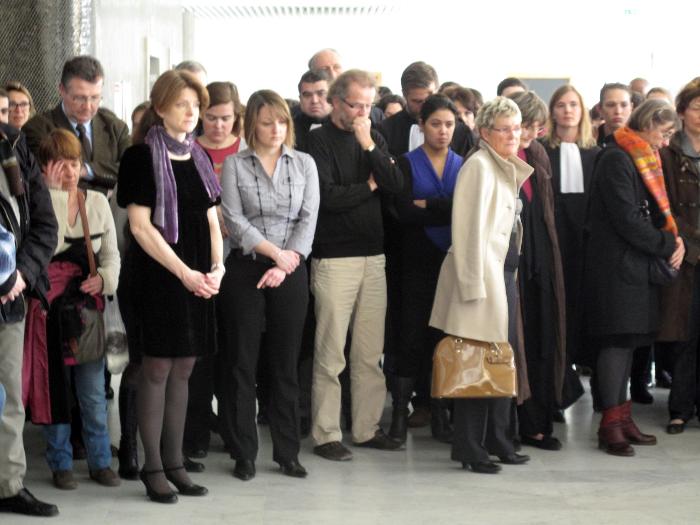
[117,71,225,503]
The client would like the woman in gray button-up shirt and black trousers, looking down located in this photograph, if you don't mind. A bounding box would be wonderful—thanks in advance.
[218,90,319,481]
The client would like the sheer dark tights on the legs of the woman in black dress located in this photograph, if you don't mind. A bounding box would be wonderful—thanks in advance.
[137,356,195,492]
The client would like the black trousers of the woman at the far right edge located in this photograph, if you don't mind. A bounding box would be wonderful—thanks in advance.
[668,266,700,421]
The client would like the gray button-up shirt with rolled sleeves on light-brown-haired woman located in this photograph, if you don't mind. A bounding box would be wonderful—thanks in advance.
[221,146,320,257]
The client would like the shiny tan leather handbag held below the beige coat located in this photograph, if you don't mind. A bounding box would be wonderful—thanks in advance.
[432,335,517,398]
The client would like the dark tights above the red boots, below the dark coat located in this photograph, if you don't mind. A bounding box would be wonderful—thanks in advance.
[596,346,634,410]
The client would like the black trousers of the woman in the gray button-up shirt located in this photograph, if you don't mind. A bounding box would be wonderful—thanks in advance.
[219,253,309,462]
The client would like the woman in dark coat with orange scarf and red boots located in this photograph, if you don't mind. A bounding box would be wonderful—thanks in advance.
[583,100,685,456]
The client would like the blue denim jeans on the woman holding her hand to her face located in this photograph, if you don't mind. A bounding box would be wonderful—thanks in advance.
[44,359,112,472]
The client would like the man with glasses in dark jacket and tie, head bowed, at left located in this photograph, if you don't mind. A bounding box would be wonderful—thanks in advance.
[22,55,131,194]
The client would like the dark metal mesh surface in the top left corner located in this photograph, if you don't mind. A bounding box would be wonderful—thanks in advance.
[0,0,93,112]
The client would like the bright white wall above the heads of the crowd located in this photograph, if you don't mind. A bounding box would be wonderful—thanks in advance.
[194,0,700,108]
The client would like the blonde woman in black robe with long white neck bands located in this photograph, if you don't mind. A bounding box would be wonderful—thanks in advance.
[542,84,600,380]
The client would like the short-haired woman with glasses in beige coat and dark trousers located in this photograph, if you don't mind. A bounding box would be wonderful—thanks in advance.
[430,97,533,474]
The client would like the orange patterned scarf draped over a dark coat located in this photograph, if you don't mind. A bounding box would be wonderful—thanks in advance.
[613,126,678,236]
